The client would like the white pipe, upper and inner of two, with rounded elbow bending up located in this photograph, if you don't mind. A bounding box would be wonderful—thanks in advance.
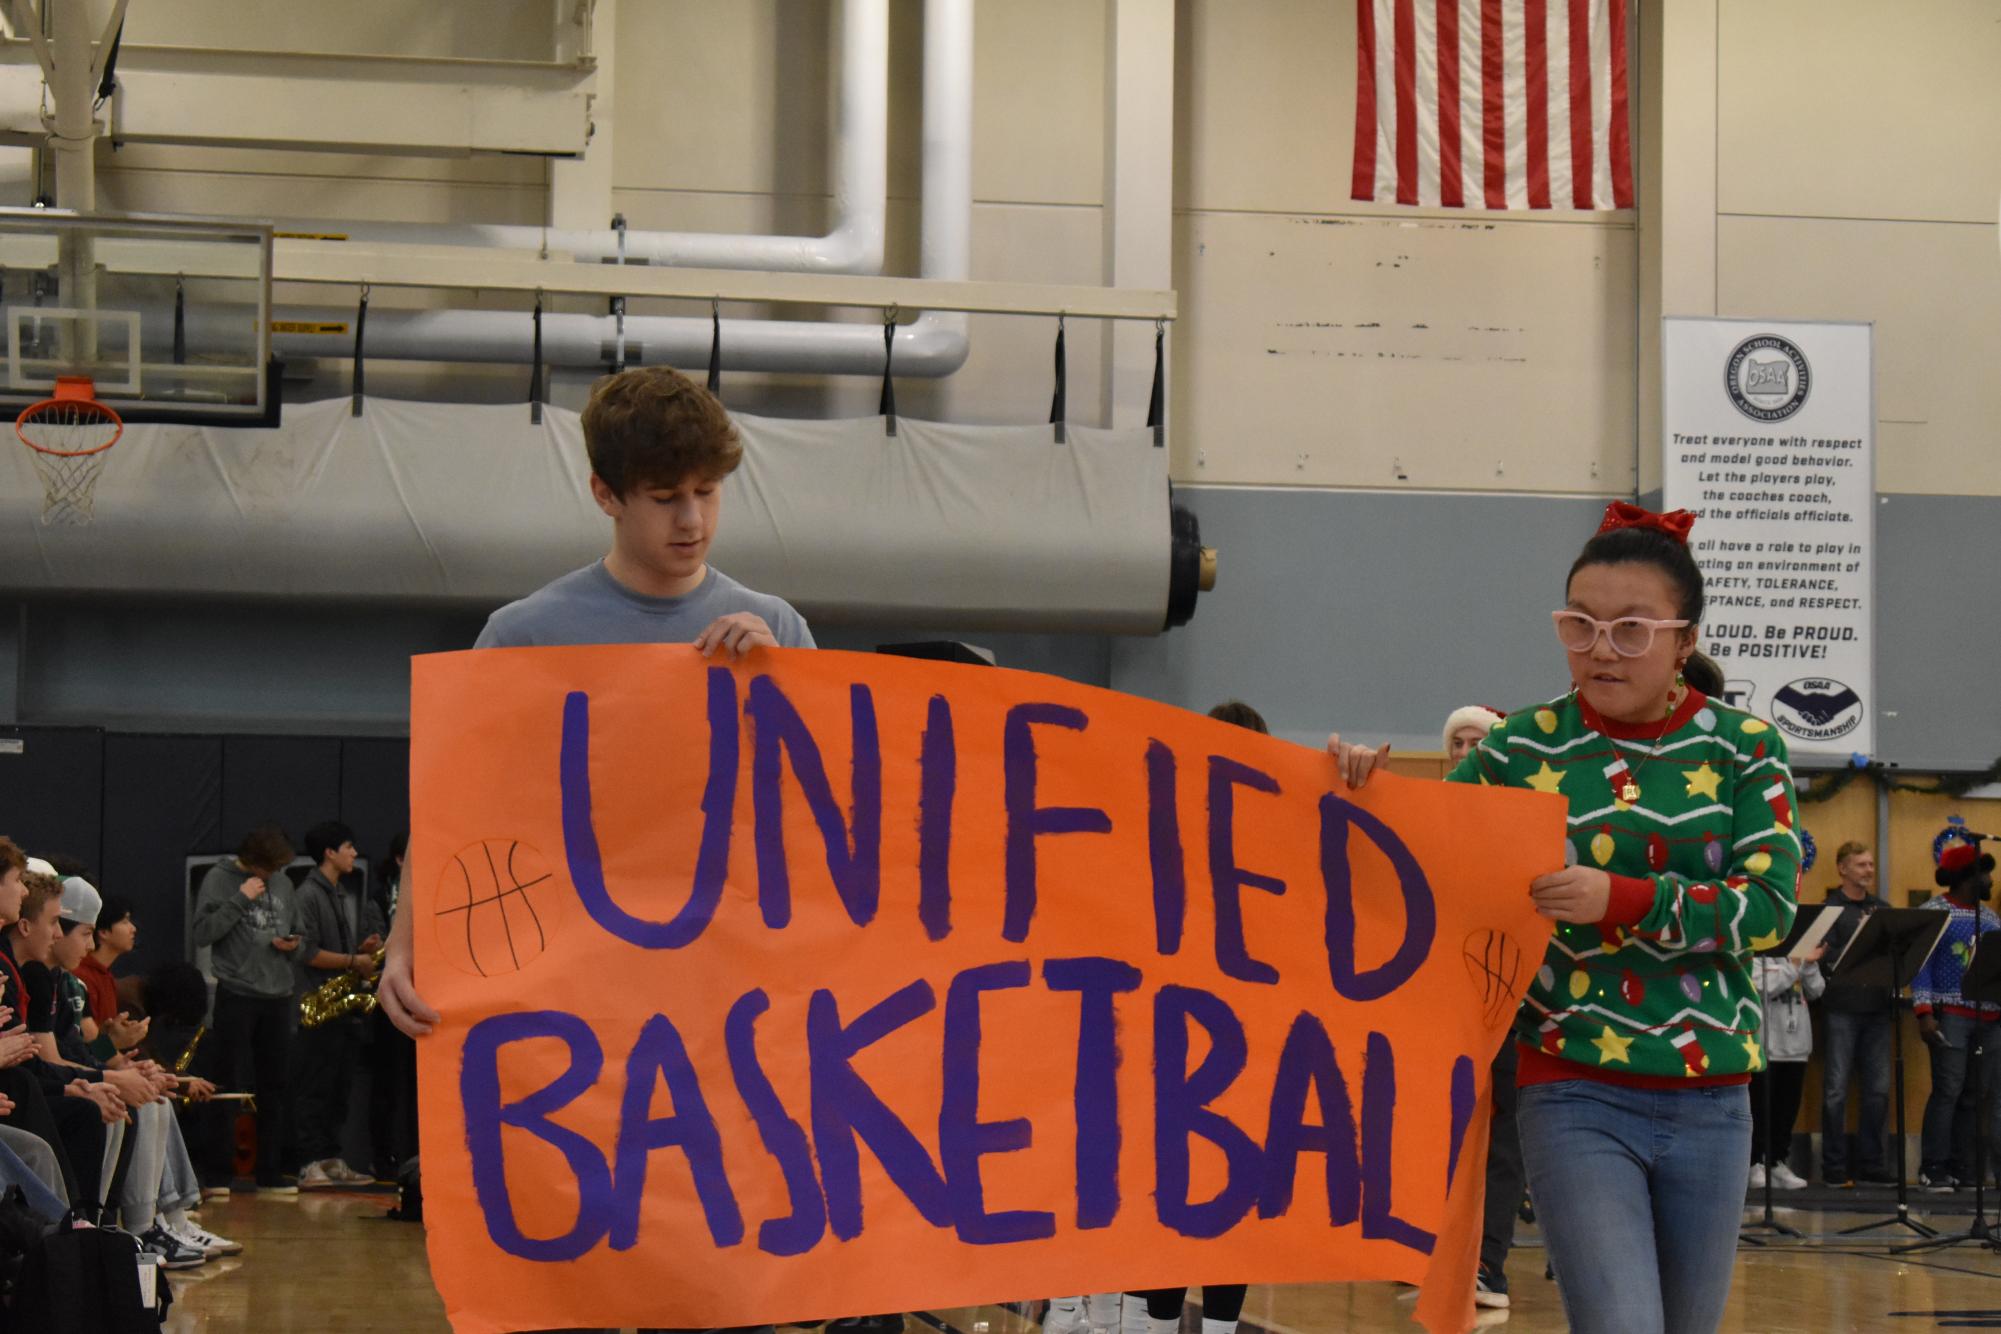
[276,0,892,276]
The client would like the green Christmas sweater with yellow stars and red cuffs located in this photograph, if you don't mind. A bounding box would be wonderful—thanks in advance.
[1449,690,1799,1088]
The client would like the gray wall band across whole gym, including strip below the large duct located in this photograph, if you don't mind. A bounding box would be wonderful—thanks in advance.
[0,488,2001,772]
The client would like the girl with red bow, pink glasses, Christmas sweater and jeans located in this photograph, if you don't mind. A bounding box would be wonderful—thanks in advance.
[1329,502,1799,1334]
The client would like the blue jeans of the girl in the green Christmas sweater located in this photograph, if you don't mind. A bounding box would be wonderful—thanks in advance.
[1519,1080,1751,1334]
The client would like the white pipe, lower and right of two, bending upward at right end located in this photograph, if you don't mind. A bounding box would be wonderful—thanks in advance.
[254,0,972,378]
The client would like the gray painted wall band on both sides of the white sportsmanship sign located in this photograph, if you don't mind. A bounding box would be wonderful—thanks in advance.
[1113,488,2001,770]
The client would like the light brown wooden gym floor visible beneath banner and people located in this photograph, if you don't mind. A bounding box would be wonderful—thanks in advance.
[166,1192,2001,1334]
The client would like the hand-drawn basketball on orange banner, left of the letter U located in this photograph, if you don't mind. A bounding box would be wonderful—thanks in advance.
[432,838,572,978]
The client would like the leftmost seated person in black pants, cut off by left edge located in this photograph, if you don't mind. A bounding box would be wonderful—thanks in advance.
[0,868,126,1220]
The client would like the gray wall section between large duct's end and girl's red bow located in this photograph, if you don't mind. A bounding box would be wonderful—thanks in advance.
[1113,488,1605,750]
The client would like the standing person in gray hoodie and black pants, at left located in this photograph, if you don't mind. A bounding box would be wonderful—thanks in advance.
[194,824,300,1194]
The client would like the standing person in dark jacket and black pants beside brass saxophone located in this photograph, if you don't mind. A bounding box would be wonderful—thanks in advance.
[292,820,388,1190]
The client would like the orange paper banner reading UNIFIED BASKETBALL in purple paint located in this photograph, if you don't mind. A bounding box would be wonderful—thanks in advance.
[410,646,1565,1334]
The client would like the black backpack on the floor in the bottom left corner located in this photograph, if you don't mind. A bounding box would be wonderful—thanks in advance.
[14,1220,172,1334]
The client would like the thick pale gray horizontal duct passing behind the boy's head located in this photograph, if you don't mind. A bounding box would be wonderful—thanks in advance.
[0,400,1193,634]
